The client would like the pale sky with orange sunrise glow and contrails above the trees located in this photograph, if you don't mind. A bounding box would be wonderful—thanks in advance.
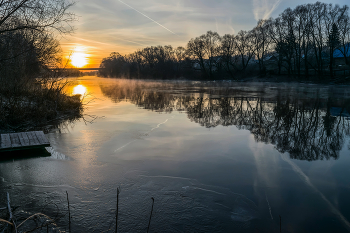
[59,0,349,68]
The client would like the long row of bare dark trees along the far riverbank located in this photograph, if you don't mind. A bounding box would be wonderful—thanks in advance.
[100,2,350,80]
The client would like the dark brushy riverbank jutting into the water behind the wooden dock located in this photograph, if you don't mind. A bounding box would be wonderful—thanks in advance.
[0,79,83,132]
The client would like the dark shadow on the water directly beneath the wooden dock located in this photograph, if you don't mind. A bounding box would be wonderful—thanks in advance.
[0,148,51,163]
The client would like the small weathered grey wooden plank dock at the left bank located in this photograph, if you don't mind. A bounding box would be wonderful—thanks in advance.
[0,131,50,152]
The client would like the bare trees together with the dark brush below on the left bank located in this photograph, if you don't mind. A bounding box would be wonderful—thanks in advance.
[0,0,82,129]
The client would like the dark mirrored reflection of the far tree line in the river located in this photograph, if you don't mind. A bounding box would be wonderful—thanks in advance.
[100,80,350,161]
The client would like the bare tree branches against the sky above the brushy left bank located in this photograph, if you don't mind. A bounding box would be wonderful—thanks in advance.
[0,0,75,78]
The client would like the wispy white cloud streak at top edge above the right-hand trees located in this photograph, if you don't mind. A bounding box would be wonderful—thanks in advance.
[253,0,282,20]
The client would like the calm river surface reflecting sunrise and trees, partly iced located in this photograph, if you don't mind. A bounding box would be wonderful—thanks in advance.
[0,77,350,233]
